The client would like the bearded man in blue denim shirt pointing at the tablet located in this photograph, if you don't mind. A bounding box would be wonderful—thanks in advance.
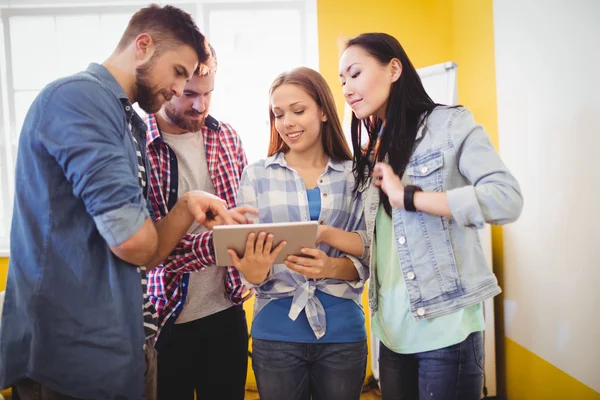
[0,6,239,399]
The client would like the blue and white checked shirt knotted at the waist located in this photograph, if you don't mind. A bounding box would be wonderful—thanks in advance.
[237,153,369,338]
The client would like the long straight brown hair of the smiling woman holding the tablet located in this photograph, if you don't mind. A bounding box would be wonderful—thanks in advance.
[268,67,352,161]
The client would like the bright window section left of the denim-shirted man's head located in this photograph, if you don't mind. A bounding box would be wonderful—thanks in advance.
[0,9,139,251]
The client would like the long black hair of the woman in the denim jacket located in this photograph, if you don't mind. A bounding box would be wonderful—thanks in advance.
[346,33,439,215]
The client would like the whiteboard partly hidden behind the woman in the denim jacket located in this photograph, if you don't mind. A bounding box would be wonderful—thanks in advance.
[343,61,496,396]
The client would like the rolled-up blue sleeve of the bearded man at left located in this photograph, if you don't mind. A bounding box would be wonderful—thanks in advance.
[39,81,150,246]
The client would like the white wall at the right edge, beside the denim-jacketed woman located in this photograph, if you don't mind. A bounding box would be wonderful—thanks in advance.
[494,0,600,391]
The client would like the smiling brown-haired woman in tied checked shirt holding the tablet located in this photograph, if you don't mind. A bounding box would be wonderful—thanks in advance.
[229,68,369,400]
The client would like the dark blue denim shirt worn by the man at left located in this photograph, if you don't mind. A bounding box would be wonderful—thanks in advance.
[0,64,149,399]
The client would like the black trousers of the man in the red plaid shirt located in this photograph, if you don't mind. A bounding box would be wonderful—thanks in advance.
[158,306,248,400]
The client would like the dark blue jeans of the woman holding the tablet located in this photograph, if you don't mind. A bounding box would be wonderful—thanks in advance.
[252,339,367,400]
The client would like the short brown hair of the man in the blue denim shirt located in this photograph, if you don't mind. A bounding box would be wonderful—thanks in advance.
[117,4,209,64]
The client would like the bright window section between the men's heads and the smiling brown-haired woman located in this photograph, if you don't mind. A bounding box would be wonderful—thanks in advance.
[204,2,317,162]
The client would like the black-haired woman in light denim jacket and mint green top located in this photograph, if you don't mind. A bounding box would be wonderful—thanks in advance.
[325,33,523,400]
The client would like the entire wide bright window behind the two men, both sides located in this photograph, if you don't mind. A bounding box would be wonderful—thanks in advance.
[0,0,317,256]
